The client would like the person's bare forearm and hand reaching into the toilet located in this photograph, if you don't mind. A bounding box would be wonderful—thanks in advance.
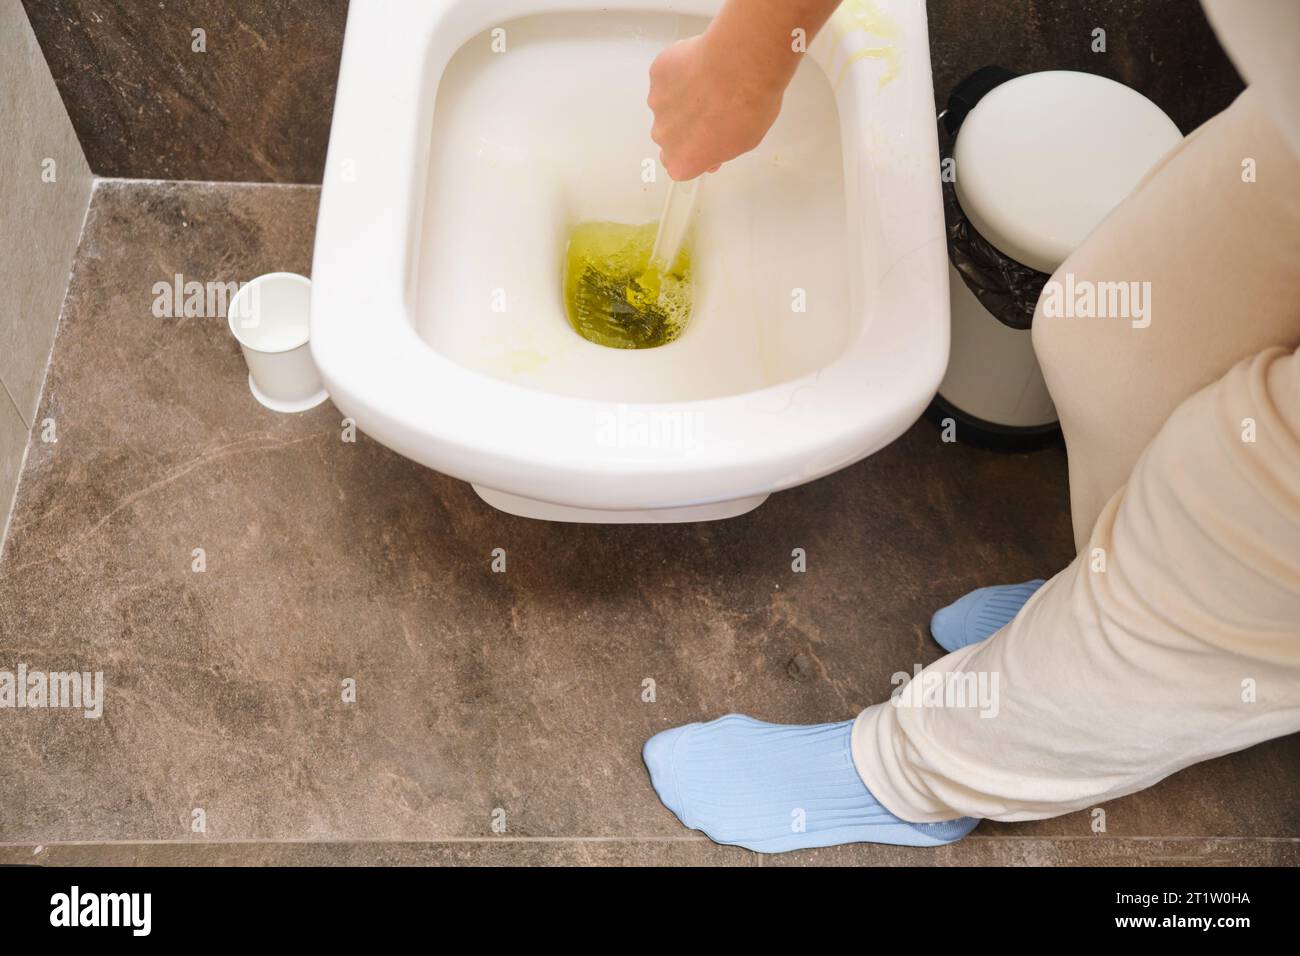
[647,0,840,179]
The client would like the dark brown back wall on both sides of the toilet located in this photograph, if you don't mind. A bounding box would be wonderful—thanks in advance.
[23,0,1240,182]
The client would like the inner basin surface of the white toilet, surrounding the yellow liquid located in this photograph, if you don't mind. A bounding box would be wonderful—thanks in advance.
[416,13,855,402]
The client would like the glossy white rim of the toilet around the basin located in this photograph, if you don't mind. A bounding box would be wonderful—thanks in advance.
[311,0,948,507]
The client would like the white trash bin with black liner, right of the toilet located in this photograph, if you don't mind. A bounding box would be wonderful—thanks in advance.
[931,68,1182,450]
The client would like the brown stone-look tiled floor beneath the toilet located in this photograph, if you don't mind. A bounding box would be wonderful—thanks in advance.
[0,182,1300,864]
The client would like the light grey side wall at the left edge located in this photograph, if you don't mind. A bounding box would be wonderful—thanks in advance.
[0,0,94,546]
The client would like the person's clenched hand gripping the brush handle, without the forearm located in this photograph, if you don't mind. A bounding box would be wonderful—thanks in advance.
[647,33,788,181]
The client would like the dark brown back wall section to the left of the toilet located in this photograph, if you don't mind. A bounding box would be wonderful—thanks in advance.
[22,0,353,182]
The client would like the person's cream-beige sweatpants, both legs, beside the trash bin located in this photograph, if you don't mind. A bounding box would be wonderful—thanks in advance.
[853,83,1300,822]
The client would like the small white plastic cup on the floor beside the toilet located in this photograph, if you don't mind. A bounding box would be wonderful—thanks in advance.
[226,272,329,412]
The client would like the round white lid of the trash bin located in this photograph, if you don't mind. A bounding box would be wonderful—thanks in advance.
[953,70,1182,273]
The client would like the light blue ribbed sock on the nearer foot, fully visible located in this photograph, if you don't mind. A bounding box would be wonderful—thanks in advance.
[645,714,979,853]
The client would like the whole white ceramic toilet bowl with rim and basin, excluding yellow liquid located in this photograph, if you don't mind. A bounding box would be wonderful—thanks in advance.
[311,0,949,522]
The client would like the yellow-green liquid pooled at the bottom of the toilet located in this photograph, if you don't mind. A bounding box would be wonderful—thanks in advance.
[564,222,690,349]
